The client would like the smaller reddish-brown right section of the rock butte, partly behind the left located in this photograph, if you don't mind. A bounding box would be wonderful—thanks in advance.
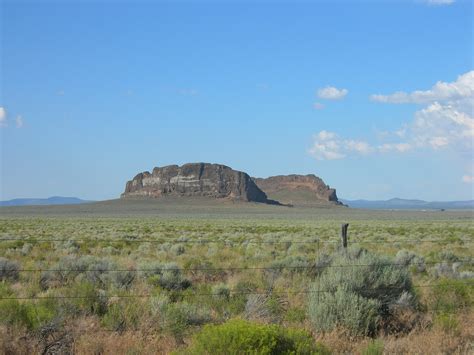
[253,174,341,205]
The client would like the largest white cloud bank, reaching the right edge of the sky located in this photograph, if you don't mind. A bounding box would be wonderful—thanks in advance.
[309,71,474,183]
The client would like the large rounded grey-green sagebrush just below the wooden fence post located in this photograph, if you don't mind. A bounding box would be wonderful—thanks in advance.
[308,250,414,335]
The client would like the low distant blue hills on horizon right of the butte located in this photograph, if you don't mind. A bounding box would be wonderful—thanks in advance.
[339,198,474,210]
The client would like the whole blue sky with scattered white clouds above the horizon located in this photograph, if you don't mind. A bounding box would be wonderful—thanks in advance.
[0,0,474,200]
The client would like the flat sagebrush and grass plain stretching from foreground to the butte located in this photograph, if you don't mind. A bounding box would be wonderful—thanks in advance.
[0,199,474,353]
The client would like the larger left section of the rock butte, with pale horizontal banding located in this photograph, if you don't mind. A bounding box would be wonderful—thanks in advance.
[121,163,269,203]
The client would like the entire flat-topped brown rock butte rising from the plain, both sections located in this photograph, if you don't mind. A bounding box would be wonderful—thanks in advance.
[121,163,341,205]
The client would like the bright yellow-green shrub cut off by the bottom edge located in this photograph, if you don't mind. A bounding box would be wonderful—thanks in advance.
[178,319,330,355]
